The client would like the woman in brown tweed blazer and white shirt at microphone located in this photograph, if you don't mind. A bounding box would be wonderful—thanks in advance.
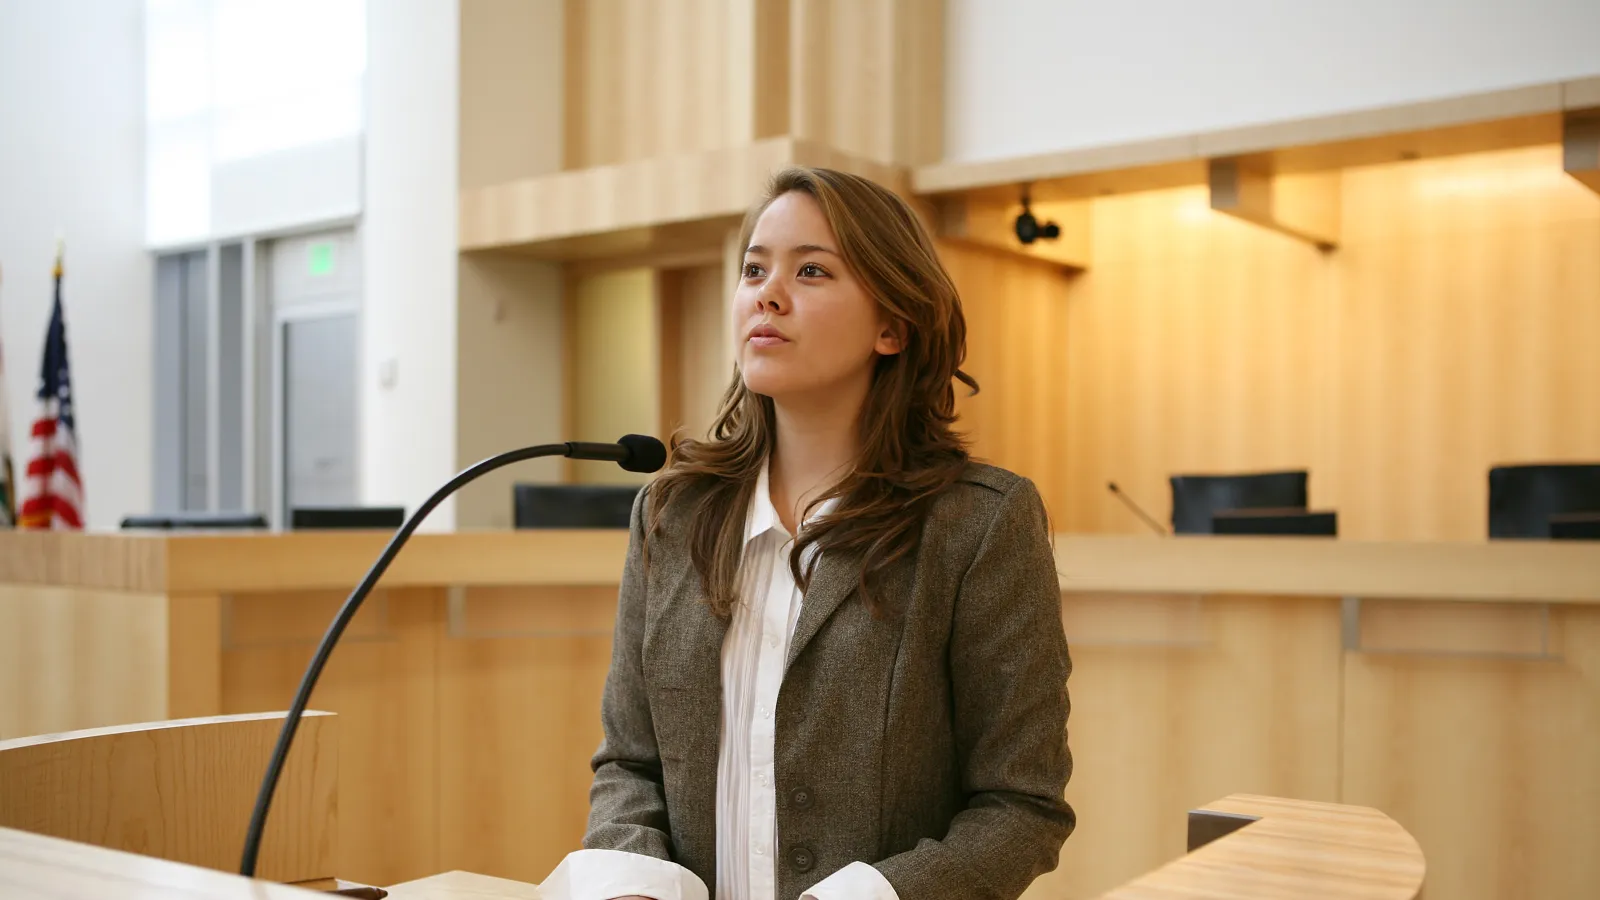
[544,168,1075,900]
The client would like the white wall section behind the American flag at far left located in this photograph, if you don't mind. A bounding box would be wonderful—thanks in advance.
[0,0,154,528]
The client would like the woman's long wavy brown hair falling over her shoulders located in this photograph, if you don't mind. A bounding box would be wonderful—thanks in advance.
[650,168,978,617]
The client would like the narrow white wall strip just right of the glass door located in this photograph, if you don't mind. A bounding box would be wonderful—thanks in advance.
[360,0,459,530]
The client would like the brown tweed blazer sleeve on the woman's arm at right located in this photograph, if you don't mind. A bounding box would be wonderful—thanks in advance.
[875,479,1077,900]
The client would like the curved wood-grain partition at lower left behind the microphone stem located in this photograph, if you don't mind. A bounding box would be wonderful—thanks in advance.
[0,711,339,881]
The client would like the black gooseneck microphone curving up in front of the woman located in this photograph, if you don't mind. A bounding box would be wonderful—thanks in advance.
[238,434,667,878]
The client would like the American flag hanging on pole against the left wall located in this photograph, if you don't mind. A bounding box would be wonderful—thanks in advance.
[18,259,83,530]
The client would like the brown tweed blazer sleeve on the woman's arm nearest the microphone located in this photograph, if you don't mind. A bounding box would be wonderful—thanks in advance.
[584,488,672,860]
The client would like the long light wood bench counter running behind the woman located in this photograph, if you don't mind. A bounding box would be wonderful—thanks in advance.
[0,532,1600,898]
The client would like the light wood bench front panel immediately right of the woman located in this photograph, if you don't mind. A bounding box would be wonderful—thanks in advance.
[1026,596,1339,900]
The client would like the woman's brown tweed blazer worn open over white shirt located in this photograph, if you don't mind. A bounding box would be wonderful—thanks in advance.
[584,464,1075,900]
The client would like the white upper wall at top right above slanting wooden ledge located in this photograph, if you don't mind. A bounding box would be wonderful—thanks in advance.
[944,0,1600,160]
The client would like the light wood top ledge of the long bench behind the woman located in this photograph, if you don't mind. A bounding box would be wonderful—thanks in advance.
[0,530,1600,604]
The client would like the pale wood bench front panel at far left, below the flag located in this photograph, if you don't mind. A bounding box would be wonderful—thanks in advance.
[0,582,168,738]
